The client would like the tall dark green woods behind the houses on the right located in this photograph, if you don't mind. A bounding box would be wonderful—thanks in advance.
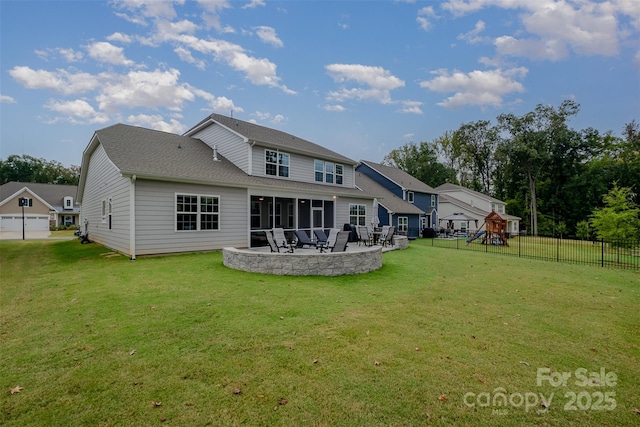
[383,100,640,239]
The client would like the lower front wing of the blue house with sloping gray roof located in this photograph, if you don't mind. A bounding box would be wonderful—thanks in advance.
[356,172,424,238]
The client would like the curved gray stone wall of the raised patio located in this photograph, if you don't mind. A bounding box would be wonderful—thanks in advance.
[222,236,409,276]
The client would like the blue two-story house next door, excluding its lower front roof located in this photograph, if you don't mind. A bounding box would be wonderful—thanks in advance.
[356,160,438,238]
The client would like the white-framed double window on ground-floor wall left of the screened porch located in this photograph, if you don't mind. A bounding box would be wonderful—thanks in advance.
[176,194,220,231]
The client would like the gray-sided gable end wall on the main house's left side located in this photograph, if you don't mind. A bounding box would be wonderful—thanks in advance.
[78,145,131,255]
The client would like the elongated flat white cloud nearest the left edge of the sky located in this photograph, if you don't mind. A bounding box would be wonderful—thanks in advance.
[9,66,104,95]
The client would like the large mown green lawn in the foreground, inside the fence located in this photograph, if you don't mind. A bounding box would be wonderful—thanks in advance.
[0,239,640,426]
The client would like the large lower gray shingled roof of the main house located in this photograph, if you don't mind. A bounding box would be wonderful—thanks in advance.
[78,124,367,201]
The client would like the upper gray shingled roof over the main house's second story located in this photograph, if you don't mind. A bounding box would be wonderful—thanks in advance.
[184,114,357,166]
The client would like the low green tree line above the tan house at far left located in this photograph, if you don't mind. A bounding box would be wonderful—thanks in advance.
[0,154,80,185]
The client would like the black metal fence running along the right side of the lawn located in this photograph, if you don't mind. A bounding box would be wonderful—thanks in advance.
[429,236,640,270]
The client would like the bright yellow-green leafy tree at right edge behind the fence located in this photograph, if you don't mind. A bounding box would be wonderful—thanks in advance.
[590,183,640,245]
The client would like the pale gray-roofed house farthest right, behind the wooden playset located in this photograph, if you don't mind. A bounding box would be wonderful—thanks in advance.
[435,183,520,235]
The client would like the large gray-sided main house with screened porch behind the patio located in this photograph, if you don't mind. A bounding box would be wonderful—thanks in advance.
[78,114,373,259]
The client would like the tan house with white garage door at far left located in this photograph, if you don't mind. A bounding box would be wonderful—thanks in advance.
[0,182,80,231]
